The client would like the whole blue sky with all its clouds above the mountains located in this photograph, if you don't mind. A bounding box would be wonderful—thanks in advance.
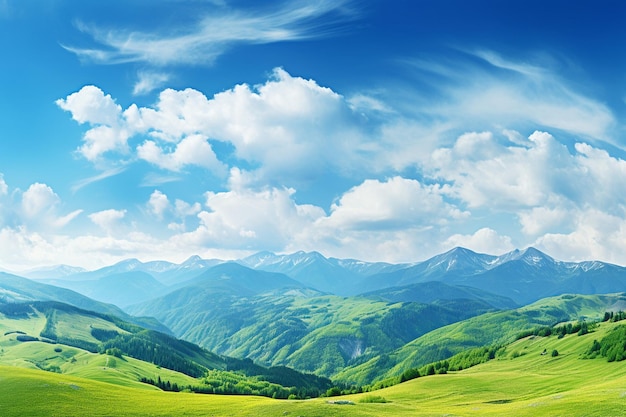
[0,0,626,271]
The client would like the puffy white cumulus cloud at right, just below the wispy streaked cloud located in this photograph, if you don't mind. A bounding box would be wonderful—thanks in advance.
[429,132,577,210]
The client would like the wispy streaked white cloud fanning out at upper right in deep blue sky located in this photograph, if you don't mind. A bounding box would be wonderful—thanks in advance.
[407,51,621,146]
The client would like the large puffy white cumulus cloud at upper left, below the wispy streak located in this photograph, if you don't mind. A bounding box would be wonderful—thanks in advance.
[57,68,370,186]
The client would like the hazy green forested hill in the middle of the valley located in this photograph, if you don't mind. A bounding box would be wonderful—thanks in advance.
[129,286,494,377]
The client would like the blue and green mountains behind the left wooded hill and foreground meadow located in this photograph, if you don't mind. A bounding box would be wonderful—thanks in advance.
[0,244,626,383]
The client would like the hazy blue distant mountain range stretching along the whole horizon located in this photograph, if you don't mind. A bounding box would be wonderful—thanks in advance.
[18,247,626,306]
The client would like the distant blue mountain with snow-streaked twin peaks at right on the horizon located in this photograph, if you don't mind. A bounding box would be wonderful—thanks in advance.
[362,247,626,304]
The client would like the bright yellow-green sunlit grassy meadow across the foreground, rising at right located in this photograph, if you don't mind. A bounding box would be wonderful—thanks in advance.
[0,322,626,416]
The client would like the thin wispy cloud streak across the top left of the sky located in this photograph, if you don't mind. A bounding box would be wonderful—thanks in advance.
[63,0,355,66]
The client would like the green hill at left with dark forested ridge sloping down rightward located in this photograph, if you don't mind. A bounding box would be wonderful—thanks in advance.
[0,301,331,396]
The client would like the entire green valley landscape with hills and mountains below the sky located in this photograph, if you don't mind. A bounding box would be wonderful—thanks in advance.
[0,248,626,416]
